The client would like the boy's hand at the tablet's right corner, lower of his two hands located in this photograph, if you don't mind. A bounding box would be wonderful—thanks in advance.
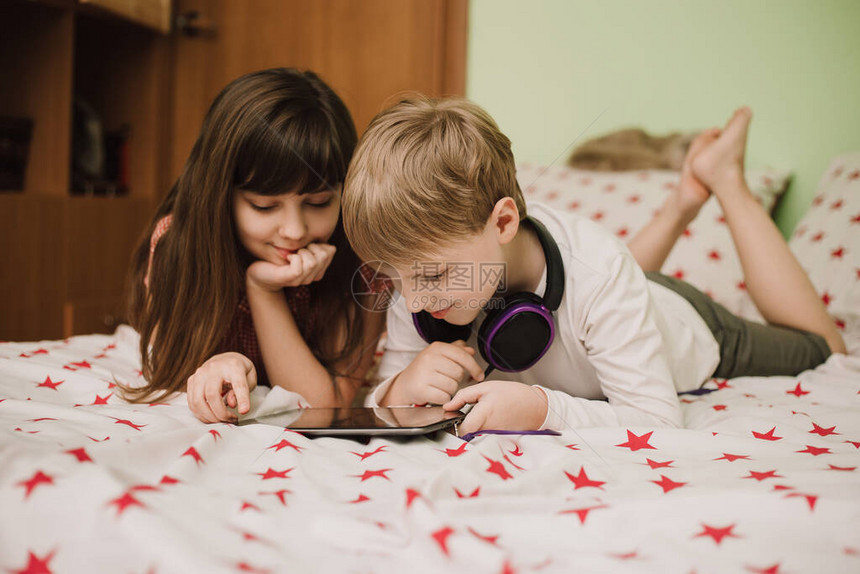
[443,381,547,436]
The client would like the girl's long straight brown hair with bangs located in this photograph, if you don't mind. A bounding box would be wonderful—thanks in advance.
[124,68,373,402]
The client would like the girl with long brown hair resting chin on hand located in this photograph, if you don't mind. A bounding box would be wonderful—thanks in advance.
[124,68,385,422]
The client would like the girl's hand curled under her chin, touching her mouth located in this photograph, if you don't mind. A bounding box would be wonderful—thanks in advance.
[247,243,336,291]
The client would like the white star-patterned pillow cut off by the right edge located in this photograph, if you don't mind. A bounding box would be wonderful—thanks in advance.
[788,151,860,354]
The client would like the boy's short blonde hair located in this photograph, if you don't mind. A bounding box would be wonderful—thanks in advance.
[342,98,526,266]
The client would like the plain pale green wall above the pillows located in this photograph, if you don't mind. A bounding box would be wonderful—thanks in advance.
[466,0,860,234]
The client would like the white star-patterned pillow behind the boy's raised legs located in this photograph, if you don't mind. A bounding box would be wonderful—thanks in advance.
[517,164,791,321]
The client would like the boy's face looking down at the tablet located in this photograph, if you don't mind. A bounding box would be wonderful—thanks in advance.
[396,225,507,325]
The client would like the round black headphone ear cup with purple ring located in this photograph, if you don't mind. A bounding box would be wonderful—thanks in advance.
[478,292,555,373]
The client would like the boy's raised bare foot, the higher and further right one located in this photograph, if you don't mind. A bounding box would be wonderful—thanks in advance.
[691,107,752,196]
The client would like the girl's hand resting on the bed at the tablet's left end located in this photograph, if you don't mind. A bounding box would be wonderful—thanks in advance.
[187,353,257,423]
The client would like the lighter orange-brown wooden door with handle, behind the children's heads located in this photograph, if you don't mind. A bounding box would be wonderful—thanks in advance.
[170,0,467,194]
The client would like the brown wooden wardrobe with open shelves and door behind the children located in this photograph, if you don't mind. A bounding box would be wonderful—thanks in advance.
[0,0,468,340]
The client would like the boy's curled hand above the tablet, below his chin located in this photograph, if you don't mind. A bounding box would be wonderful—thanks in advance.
[380,341,484,406]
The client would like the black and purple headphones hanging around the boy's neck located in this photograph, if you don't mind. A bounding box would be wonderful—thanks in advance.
[412,217,564,375]
